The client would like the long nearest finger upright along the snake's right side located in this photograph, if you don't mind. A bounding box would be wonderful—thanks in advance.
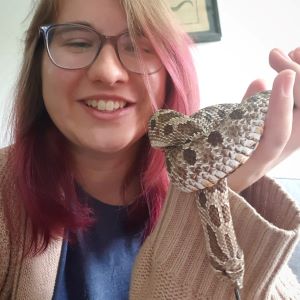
[228,70,295,192]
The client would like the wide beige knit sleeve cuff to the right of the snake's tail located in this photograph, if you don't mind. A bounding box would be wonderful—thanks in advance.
[230,177,300,299]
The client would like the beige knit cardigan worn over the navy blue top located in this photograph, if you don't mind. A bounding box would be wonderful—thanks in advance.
[0,151,300,300]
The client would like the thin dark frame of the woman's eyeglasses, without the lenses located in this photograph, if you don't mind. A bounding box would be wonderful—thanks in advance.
[39,23,163,75]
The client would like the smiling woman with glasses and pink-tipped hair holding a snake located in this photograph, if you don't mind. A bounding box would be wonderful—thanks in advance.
[0,0,300,299]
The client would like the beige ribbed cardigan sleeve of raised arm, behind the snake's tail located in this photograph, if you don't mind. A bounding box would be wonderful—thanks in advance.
[130,178,300,300]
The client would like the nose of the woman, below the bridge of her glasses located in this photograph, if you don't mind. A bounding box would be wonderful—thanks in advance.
[88,44,129,86]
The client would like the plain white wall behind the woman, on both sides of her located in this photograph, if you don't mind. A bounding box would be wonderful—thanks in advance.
[0,0,300,178]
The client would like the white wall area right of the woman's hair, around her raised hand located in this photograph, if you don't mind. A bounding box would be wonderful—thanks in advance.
[192,0,300,178]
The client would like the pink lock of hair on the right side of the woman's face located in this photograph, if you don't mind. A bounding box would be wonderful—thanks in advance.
[125,1,200,236]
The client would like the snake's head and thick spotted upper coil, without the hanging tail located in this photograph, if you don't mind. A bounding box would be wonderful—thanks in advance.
[149,91,270,192]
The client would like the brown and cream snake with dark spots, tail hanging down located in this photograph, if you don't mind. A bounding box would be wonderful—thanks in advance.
[148,91,271,299]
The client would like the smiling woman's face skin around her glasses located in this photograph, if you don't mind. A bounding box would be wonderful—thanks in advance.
[42,0,167,153]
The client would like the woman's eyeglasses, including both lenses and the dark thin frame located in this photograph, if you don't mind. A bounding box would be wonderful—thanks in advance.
[40,24,162,75]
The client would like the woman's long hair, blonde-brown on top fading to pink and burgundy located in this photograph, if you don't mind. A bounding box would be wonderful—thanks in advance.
[3,0,199,255]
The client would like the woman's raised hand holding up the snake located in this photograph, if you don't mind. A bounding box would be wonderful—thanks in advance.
[228,48,300,192]
